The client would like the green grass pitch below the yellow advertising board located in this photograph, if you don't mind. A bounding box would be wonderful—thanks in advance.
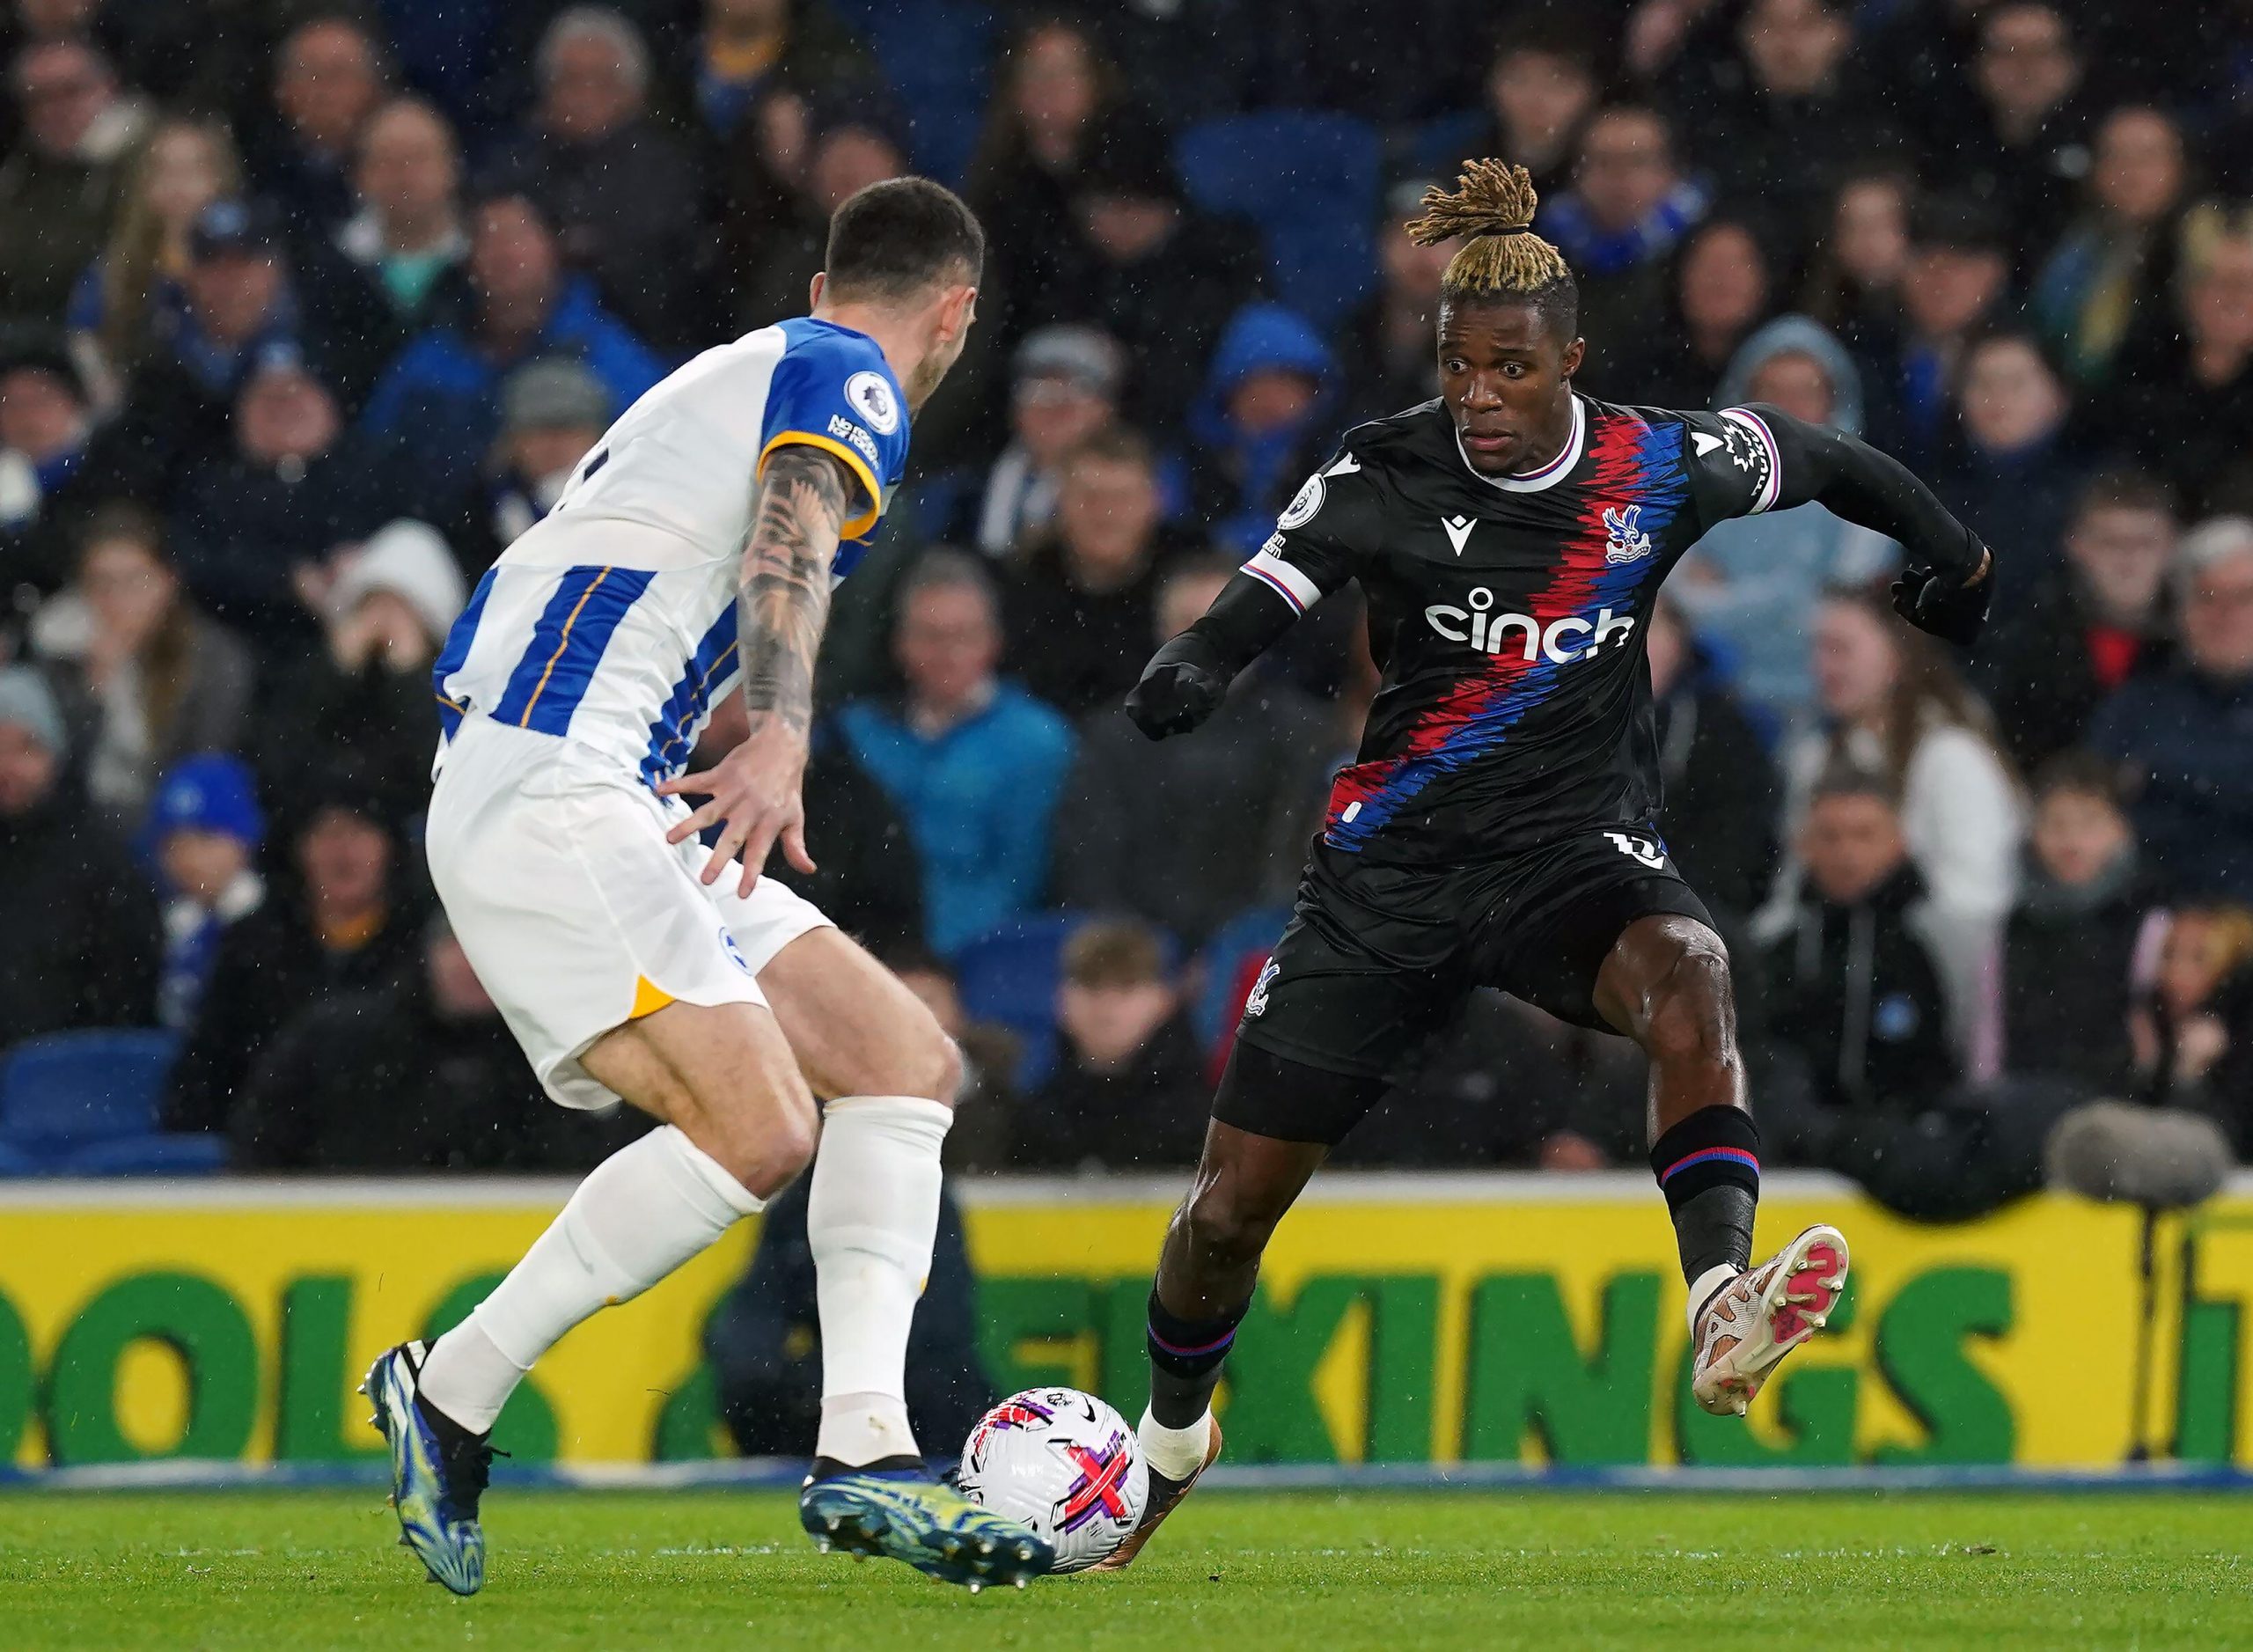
[0,1487,2253,1652]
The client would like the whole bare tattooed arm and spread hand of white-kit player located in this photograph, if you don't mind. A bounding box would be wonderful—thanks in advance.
[658,444,856,895]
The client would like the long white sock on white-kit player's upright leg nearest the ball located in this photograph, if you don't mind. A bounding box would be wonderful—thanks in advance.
[806,1096,955,1463]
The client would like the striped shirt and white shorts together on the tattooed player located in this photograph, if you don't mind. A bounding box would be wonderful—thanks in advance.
[428,318,908,1106]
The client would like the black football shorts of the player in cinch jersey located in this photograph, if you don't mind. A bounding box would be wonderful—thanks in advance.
[1223,829,1713,1082]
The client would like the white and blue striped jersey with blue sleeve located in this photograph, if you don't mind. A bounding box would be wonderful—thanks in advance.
[430,318,908,784]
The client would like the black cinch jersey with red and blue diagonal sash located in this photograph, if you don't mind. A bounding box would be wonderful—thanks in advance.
[1244,397,1805,865]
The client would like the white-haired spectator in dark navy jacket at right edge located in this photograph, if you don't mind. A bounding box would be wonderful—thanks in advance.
[2091,516,2253,904]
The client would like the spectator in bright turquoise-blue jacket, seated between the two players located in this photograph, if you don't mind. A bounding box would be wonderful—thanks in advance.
[842,550,1075,953]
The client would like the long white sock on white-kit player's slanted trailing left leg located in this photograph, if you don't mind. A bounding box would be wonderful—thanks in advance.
[419,1125,764,1434]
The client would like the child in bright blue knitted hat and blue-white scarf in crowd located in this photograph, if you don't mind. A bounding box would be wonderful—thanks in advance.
[146,751,266,1032]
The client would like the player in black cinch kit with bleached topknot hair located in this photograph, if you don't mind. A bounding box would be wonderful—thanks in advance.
[1090,162,1994,1564]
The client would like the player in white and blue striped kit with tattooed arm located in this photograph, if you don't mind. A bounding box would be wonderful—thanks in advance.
[365,178,1053,1593]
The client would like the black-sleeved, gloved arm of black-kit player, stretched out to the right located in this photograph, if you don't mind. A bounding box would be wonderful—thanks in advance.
[1753,406,1994,647]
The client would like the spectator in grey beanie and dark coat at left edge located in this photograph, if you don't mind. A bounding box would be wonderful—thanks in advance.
[0,664,158,1050]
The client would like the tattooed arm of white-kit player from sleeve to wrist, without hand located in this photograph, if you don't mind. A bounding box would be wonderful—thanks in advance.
[737,444,849,735]
